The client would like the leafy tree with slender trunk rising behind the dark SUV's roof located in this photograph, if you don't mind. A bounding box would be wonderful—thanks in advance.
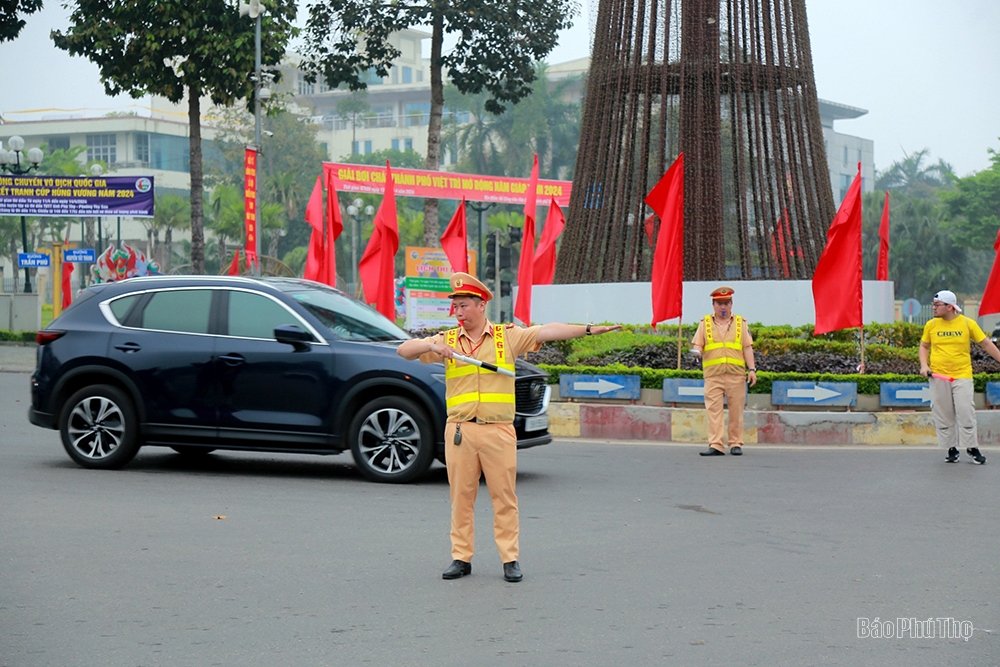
[52,0,296,273]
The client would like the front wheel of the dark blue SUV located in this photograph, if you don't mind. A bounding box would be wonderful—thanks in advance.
[347,396,434,483]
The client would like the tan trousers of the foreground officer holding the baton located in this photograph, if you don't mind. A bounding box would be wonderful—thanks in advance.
[444,422,519,563]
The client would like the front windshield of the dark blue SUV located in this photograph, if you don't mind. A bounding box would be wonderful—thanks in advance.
[289,286,410,341]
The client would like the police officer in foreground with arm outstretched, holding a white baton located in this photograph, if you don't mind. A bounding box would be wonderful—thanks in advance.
[399,273,621,582]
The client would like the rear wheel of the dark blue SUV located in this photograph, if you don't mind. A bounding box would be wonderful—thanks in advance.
[59,384,139,470]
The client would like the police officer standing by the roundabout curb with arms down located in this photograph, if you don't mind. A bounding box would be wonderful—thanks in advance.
[691,287,757,456]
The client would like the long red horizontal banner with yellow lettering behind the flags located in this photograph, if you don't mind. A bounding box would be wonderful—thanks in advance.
[323,162,573,207]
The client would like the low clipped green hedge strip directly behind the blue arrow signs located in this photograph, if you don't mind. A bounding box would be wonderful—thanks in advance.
[539,364,1000,395]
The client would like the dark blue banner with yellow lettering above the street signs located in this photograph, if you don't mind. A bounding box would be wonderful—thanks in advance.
[0,175,153,218]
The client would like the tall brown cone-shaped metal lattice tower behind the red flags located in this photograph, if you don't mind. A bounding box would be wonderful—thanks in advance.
[556,0,835,283]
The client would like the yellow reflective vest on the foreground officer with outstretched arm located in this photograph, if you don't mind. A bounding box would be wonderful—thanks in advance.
[444,324,514,423]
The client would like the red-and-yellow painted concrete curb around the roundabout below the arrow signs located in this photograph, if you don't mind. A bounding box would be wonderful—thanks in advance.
[548,403,1000,446]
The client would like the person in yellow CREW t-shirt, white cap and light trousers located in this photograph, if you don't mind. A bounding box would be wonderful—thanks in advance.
[920,290,1000,465]
